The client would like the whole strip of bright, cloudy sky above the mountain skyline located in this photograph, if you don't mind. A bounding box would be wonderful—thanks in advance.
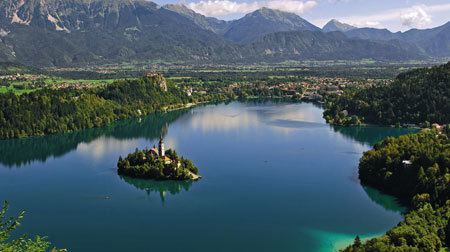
[155,0,450,32]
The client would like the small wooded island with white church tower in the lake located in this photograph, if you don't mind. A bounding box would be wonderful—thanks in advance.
[117,136,201,180]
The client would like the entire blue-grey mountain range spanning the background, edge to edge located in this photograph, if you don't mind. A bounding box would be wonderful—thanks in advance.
[0,0,450,66]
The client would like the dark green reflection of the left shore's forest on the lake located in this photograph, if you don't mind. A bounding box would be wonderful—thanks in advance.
[0,110,187,167]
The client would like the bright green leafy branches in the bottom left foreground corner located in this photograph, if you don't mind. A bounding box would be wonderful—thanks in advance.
[0,201,67,252]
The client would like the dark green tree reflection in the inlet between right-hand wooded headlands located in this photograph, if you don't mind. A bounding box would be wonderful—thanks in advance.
[331,125,417,146]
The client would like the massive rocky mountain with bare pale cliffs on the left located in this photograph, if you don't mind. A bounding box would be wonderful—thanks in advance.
[0,0,236,66]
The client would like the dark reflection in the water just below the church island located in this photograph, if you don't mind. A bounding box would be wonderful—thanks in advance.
[120,176,195,202]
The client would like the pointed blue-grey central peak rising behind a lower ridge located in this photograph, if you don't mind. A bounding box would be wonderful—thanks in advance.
[224,8,320,43]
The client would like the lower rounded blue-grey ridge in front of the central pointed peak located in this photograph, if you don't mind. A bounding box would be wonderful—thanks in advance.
[246,31,426,61]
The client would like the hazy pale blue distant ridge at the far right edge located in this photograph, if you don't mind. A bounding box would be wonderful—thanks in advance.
[345,22,450,57]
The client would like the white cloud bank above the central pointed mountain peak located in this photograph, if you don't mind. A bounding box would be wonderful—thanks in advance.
[187,0,317,16]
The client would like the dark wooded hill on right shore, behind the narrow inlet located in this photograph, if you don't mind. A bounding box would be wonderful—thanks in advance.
[324,62,450,126]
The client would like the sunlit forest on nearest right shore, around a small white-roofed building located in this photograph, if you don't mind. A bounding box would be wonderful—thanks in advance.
[343,128,450,252]
